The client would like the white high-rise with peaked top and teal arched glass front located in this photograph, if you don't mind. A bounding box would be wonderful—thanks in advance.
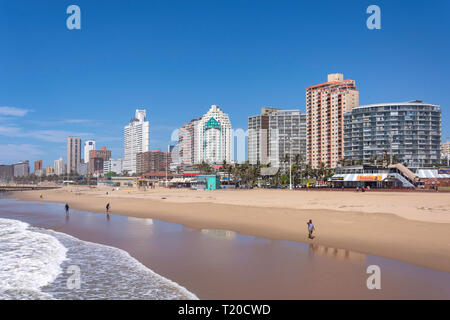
[194,105,232,164]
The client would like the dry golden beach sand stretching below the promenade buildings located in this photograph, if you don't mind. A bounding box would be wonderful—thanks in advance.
[13,187,450,272]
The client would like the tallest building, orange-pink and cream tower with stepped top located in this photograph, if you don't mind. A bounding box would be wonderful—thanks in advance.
[306,73,359,168]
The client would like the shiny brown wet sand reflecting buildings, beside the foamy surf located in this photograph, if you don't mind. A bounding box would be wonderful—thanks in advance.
[0,199,450,299]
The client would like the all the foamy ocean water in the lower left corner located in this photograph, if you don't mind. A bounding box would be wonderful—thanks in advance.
[0,218,197,300]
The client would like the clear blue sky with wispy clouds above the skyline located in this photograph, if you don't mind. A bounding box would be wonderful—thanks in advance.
[0,0,450,166]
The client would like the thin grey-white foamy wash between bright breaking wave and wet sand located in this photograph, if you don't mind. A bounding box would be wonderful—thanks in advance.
[42,230,198,300]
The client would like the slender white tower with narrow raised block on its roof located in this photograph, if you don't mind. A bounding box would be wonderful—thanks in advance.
[122,109,150,174]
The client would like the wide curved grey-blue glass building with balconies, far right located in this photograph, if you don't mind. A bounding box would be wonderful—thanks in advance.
[344,100,441,167]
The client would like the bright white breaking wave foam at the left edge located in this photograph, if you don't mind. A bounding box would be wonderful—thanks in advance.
[0,218,67,299]
